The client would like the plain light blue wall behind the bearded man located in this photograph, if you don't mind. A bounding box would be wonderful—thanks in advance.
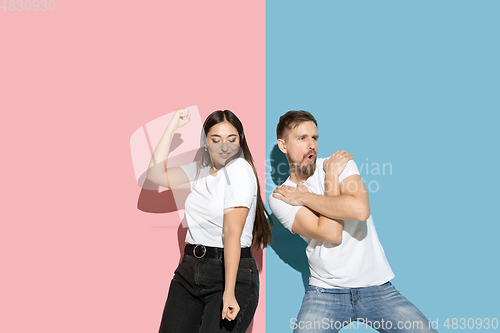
[266,0,500,333]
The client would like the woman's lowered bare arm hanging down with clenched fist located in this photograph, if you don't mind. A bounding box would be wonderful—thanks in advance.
[222,207,248,320]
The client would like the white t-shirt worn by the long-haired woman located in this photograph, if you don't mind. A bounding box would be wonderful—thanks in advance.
[181,158,257,247]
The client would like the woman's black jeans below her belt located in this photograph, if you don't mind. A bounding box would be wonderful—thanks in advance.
[159,254,259,333]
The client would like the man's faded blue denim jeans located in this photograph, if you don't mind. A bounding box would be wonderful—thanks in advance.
[290,282,437,333]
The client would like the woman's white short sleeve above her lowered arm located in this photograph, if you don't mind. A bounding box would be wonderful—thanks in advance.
[221,158,257,209]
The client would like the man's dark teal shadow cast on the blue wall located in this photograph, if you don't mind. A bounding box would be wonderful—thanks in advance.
[270,145,309,290]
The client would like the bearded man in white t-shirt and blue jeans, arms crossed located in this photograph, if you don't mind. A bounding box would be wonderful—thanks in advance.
[269,111,436,333]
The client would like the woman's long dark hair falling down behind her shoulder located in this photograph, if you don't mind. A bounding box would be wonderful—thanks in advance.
[200,110,273,247]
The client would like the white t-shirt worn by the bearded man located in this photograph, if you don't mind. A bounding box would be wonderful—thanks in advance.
[269,158,394,288]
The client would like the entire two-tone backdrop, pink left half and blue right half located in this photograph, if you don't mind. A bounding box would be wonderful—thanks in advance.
[0,0,500,333]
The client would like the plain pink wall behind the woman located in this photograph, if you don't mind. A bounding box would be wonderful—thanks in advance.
[0,0,265,333]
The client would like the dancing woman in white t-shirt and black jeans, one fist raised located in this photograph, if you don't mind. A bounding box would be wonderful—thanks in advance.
[147,109,272,333]
